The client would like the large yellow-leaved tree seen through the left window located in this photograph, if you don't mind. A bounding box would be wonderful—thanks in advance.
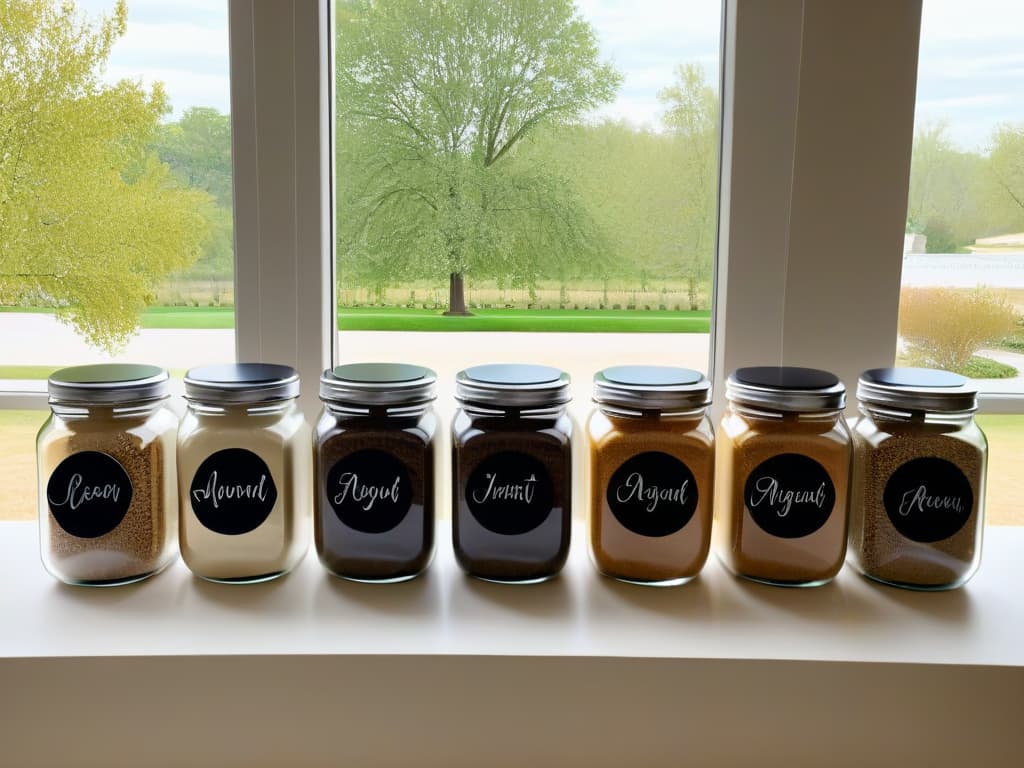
[0,0,208,346]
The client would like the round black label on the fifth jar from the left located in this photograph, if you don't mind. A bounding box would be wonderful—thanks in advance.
[605,451,697,537]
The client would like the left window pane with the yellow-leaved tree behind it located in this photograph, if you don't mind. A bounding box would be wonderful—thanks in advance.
[0,0,234,389]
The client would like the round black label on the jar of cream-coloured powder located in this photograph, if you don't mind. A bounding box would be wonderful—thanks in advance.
[188,449,278,536]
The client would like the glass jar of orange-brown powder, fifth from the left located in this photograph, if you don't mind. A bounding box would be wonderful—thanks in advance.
[587,366,715,586]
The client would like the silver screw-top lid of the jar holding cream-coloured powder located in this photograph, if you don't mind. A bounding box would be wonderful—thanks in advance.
[185,362,299,406]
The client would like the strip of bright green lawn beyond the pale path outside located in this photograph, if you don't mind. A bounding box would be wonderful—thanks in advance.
[0,306,711,334]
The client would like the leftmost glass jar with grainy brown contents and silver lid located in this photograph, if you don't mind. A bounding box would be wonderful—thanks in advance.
[36,365,178,587]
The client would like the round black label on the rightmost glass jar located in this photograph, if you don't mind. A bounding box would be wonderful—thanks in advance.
[883,457,974,543]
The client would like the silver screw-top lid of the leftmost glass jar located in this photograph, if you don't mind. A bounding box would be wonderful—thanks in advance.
[47,362,170,406]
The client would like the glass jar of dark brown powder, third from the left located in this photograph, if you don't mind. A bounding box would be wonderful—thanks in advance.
[313,362,437,582]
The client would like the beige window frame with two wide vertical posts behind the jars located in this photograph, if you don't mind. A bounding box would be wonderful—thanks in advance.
[0,0,1024,415]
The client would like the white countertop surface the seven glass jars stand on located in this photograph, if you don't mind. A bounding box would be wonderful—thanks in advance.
[0,522,1024,666]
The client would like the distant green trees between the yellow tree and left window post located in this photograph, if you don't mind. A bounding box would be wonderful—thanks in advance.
[151,106,234,281]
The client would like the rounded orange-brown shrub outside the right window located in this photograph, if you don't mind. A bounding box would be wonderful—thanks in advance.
[899,288,1016,371]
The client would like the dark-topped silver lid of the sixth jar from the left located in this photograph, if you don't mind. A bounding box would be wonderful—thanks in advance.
[725,366,846,413]
